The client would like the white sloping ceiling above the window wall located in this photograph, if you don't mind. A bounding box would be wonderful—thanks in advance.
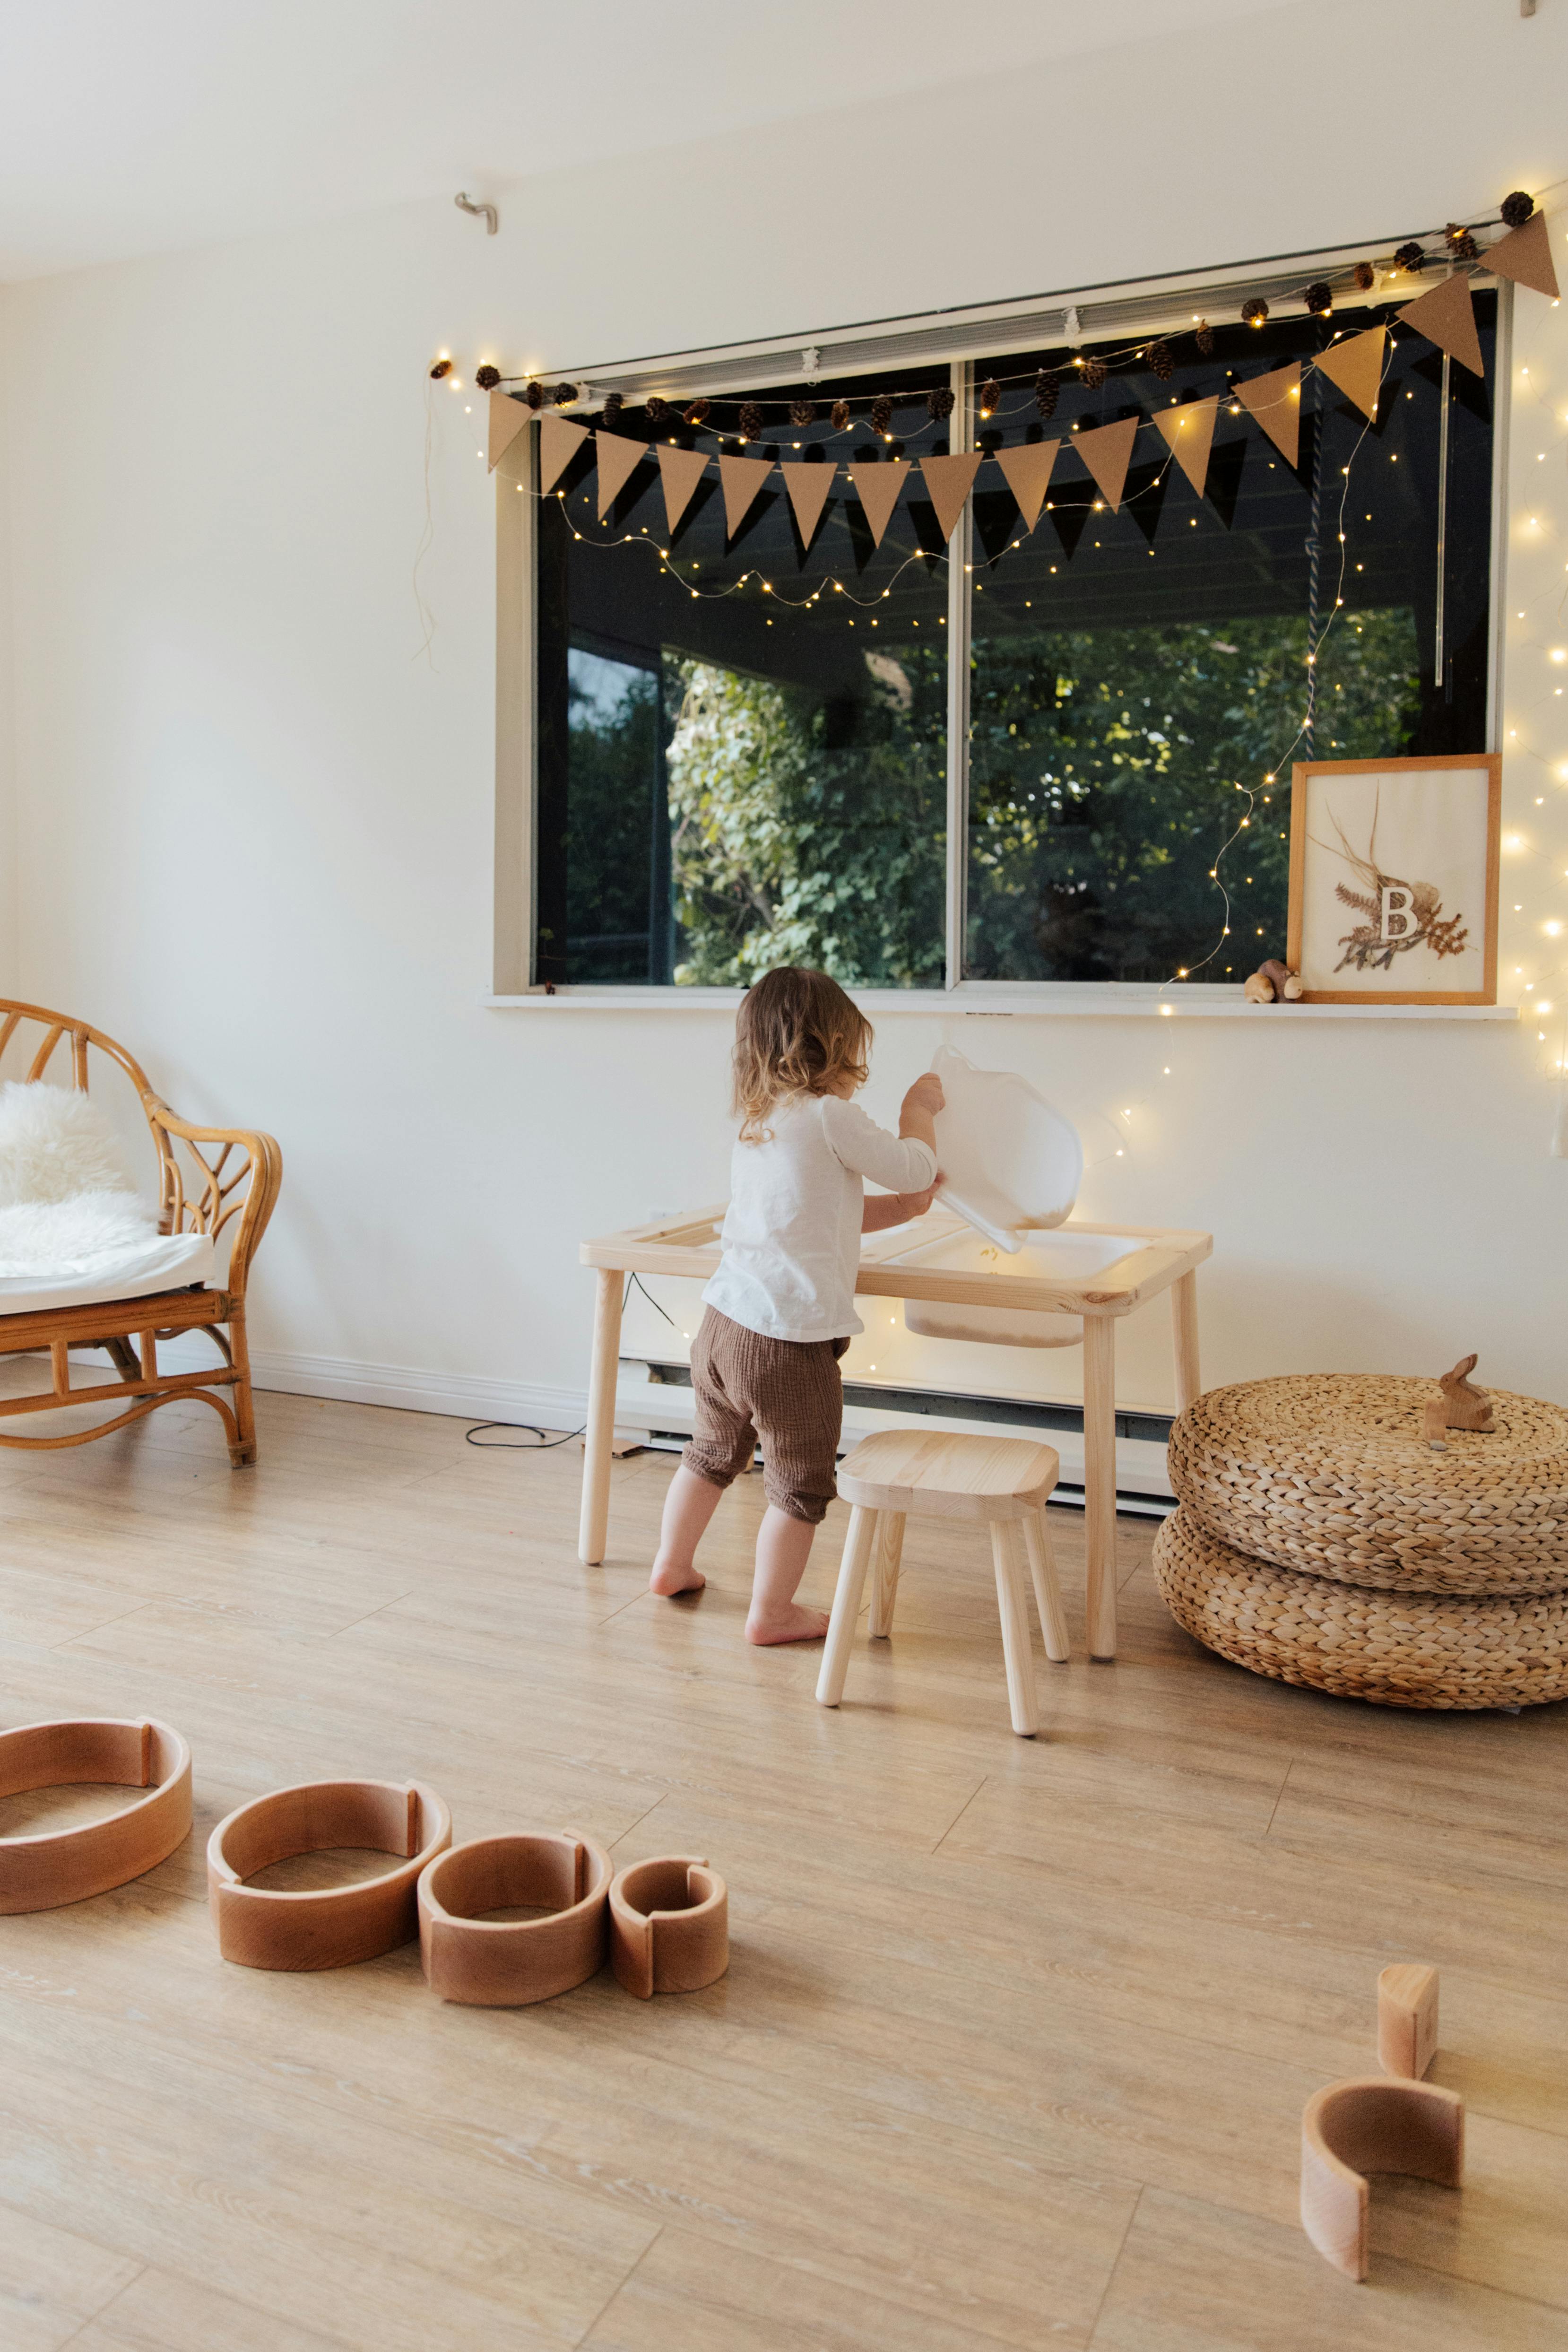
[0,0,1286,280]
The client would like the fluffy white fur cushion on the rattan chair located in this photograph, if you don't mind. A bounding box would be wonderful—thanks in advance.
[0,1084,157,1275]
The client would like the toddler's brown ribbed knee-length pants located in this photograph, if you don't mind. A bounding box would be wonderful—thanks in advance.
[682,1308,849,1527]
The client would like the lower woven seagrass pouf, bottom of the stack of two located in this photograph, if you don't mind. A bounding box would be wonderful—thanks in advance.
[1154,1503,1568,1708]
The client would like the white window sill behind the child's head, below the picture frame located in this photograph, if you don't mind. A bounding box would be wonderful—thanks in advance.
[479,981,1519,1021]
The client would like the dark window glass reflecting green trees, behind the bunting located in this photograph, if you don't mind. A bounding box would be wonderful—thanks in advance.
[512,294,1495,990]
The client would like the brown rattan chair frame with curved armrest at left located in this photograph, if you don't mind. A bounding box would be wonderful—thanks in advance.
[0,997,282,1467]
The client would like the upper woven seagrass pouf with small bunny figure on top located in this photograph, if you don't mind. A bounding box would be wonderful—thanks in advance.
[1171,1373,1568,1597]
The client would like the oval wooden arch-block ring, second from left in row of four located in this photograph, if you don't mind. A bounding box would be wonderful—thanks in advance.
[207,1780,451,1969]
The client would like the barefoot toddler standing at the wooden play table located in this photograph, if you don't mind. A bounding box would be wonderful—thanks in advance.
[649,964,943,1642]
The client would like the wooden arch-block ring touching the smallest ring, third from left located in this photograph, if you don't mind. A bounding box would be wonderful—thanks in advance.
[418,1830,611,2009]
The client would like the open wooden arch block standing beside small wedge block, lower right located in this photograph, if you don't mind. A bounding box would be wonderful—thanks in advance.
[1302,2074,1464,2279]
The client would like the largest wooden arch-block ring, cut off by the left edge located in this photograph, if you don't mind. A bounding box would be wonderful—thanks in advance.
[0,1715,191,1912]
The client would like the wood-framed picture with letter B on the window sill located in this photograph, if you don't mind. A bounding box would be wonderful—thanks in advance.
[1286,753,1502,1004]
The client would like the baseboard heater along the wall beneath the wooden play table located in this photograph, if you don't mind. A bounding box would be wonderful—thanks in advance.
[616,1357,1176,1519]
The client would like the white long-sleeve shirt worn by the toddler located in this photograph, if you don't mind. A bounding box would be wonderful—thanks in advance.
[703,1094,936,1341]
